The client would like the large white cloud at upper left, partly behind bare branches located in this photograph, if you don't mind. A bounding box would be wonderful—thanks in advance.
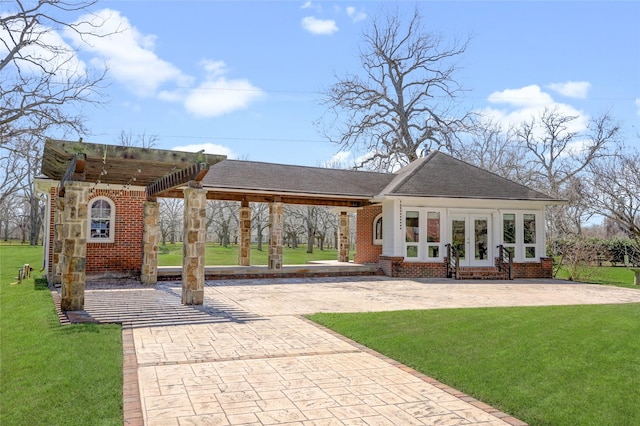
[66,9,191,96]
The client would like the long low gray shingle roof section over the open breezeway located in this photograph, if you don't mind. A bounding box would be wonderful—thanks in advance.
[202,160,395,198]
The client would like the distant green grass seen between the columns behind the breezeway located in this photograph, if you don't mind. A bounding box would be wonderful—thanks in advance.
[158,243,354,266]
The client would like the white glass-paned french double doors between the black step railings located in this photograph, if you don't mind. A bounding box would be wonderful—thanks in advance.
[450,214,493,266]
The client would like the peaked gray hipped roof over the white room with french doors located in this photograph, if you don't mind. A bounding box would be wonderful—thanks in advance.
[379,151,557,201]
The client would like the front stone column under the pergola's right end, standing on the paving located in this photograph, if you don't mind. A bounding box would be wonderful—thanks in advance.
[182,187,207,305]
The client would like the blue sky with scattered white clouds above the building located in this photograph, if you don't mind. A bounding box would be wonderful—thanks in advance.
[42,0,640,166]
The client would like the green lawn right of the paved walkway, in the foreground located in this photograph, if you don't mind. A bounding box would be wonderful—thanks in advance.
[310,304,640,425]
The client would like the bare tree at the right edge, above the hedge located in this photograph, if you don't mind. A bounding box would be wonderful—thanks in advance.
[580,151,640,244]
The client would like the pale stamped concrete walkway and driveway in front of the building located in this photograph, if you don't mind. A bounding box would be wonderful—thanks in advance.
[65,277,640,426]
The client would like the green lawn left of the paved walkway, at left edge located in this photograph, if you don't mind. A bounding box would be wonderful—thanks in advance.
[0,244,122,425]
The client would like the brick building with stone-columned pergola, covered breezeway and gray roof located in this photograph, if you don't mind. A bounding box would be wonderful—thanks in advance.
[36,140,562,309]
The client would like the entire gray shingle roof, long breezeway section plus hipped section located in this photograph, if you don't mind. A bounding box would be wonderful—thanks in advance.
[202,151,559,201]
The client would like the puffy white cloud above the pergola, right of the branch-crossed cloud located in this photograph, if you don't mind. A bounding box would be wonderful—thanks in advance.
[182,61,264,117]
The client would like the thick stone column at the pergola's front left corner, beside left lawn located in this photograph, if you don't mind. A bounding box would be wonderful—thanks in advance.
[60,182,89,311]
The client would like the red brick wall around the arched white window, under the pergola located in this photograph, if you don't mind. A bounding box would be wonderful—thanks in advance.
[49,188,146,276]
